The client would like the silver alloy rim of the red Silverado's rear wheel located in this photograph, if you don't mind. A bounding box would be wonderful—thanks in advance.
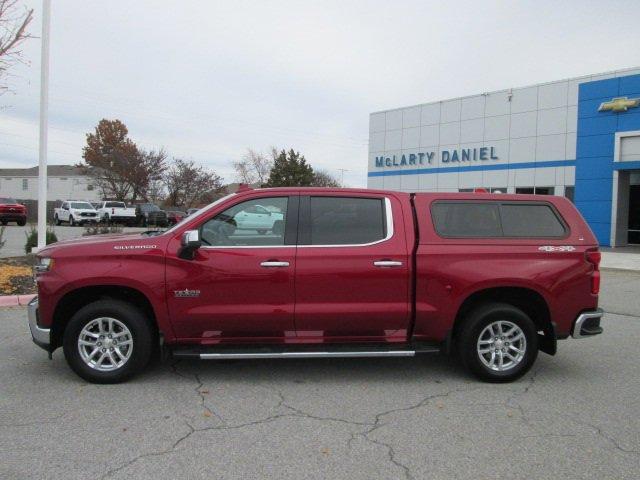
[478,320,527,372]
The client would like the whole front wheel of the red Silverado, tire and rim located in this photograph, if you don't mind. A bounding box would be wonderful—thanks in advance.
[63,300,154,383]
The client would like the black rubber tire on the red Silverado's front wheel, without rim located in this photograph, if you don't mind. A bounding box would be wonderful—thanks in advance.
[63,299,155,383]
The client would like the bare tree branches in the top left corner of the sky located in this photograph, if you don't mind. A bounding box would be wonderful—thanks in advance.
[0,0,33,95]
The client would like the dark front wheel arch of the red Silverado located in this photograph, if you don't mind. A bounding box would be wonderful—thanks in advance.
[51,285,159,348]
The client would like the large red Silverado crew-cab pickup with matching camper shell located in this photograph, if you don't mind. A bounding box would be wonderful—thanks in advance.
[28,188,602,383]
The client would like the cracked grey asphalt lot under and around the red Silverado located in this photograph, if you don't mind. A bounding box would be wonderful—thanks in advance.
[0,271,640,479]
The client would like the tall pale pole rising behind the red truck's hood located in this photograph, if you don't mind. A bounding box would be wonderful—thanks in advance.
[38,0,51,250]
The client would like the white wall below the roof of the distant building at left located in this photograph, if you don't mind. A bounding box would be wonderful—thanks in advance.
[0,176,101,202]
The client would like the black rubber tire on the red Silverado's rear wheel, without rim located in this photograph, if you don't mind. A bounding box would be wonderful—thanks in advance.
[456,303,538,382]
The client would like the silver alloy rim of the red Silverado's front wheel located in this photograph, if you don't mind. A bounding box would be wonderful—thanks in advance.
[78,317,133,372]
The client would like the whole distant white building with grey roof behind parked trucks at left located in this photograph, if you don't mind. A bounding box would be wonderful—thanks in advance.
[0,165,101,201]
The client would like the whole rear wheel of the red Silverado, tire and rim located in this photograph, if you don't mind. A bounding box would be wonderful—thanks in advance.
[458,303,538,382]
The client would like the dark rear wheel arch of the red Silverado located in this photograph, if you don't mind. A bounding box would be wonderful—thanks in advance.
[447,286,557,355]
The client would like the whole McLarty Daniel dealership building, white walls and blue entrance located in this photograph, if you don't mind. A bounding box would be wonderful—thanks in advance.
[367,68,640,246]
